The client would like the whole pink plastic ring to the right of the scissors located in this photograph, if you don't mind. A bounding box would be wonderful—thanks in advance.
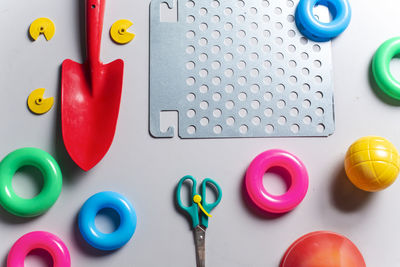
[245,149,308,213]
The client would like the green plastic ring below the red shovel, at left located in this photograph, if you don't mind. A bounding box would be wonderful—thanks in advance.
[0,147,62,217]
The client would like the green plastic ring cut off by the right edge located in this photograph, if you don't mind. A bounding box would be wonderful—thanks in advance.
[372,37,400,100]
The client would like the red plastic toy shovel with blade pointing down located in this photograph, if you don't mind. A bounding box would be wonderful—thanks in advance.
[61,0,124,171]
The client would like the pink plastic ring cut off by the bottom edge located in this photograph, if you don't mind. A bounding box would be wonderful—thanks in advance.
[7,231,71,267]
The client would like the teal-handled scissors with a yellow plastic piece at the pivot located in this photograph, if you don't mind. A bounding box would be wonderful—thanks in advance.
[176,175,222,267]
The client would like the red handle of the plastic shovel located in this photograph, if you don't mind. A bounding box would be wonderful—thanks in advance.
[86,0,106,66]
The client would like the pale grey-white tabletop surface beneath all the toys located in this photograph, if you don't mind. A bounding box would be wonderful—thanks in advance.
[0,0,400,267]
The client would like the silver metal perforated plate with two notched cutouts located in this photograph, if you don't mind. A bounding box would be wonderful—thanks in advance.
[150,0,334,138]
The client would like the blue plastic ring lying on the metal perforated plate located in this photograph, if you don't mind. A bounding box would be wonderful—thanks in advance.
[295,0,351,42]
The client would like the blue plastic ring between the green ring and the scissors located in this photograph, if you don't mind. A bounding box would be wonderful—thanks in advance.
[78,191,137,250]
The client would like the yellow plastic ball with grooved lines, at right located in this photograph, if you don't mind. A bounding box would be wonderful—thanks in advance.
[344,136,400,192]
